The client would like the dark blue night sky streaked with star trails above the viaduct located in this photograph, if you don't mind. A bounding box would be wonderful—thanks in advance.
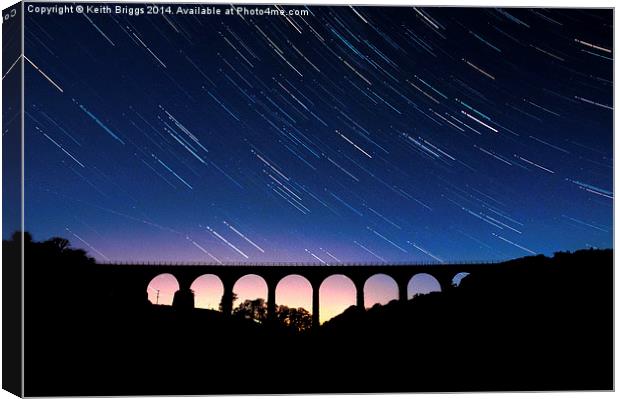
[17,5,613,263]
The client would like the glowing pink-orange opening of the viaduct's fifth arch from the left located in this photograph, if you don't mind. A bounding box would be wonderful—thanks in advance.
[319,274,357,323]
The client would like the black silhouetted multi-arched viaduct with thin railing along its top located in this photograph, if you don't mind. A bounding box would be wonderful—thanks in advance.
[97,262,504,326]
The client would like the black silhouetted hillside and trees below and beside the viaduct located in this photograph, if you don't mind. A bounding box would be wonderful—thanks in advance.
[3,233,613,396]
